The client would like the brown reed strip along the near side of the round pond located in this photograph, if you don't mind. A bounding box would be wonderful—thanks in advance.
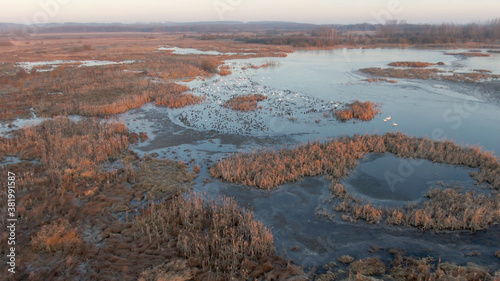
[328,182,500,231]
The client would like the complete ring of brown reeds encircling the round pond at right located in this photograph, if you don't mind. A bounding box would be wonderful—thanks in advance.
[210,133,500,231]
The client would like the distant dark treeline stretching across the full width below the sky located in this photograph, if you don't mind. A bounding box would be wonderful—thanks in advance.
[4,18,500,47]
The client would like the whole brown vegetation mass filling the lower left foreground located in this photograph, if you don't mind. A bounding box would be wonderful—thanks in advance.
[0,117,303,280]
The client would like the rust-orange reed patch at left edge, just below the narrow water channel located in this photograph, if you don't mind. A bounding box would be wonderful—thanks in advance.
[0,117,128,171]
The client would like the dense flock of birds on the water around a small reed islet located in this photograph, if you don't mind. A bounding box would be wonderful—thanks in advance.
[170,63,341,134]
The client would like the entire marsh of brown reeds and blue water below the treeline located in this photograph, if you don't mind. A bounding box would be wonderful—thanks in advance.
[0,31,500,280]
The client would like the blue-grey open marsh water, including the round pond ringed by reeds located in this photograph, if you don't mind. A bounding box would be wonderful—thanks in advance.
[124,49,500,272]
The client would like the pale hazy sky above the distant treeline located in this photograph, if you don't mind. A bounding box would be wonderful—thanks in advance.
[0,0,500,24]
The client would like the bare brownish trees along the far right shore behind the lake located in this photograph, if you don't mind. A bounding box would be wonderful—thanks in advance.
[237,19,500,47]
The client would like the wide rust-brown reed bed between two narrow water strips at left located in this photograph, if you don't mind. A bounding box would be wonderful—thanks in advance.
[0,63,206,120]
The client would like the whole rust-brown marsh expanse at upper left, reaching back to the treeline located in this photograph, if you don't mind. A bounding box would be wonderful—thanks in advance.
[0,33,292,121]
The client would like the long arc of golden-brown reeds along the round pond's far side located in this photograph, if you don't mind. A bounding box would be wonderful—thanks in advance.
[210,133,500,190]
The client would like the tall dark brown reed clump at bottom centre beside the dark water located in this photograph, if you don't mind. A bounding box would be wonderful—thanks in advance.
[134,195,305,280]
